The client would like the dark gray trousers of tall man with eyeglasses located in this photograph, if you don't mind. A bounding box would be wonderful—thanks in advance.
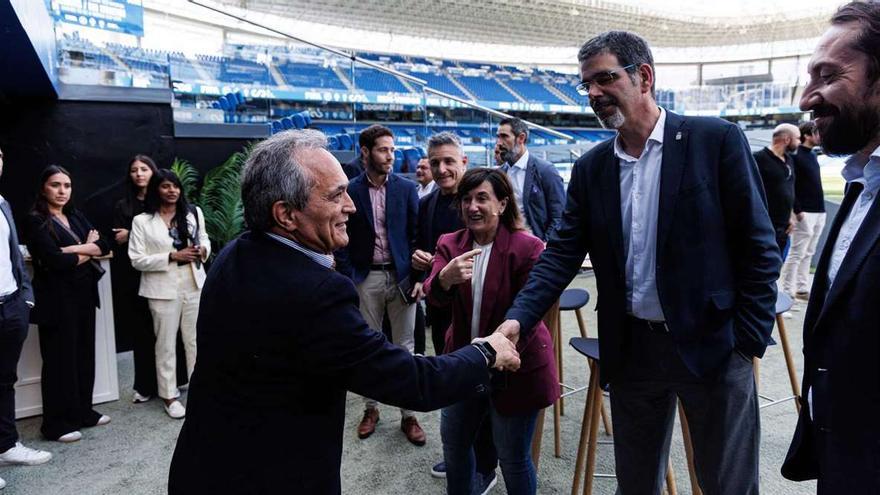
[611,326,760,495]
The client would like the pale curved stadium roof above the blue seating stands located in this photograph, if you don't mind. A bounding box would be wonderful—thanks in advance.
[216,0,841,48]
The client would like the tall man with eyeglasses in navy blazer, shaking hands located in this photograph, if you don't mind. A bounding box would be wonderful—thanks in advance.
[497,31,780,495]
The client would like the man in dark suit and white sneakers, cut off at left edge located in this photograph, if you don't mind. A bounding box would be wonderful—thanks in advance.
[0,145,52,488]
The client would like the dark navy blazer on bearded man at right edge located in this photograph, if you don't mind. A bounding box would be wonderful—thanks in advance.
[782,180,880,494]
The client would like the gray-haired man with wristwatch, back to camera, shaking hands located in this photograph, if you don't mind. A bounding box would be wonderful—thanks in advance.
[168,130,519,494]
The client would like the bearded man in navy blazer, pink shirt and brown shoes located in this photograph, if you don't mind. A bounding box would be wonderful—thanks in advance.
[337,125,425,446]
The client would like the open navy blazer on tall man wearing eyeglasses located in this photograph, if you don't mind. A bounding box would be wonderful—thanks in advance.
[507,112,781,383]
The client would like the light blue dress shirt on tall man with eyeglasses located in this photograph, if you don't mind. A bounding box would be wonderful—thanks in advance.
[614,108,666,321]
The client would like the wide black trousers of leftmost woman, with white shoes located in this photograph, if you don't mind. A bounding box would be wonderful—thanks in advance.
[39,294,101,440]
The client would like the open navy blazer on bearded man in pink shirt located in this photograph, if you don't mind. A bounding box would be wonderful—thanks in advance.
[336,173,419,284]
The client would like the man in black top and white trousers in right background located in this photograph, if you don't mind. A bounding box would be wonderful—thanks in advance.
[780,122,825,301]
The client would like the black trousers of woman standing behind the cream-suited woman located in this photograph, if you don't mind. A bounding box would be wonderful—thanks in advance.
[131,295,188,397]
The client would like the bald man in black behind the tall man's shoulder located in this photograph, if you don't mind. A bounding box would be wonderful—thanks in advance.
[755,124,801,253]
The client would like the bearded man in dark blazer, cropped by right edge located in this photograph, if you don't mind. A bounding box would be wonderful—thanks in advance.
[782,2,880,494]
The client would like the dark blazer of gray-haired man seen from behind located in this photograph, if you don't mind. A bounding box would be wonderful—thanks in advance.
[168,232,489,495]
